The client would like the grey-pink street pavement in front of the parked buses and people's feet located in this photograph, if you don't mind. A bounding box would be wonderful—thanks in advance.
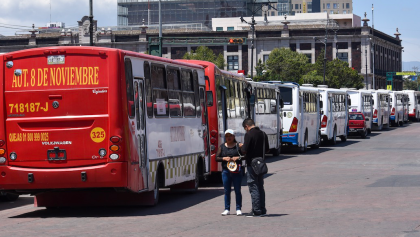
[0,123,420,237]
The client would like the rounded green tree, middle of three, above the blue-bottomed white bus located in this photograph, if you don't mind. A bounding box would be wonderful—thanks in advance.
[264,48,310,82]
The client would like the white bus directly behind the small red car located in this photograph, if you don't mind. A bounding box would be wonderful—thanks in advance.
[347,90,373,133]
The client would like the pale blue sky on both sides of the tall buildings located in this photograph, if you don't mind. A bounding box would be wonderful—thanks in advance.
[0,0,420,62]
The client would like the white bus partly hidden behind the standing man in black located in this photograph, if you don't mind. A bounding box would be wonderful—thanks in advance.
[249,82,282,156]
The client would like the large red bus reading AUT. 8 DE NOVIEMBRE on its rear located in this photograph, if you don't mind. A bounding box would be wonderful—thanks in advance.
[0,47,210,207]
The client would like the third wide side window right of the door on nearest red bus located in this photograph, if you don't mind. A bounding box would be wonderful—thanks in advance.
[182,71,196,117]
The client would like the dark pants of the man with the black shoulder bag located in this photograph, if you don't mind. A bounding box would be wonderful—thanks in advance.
[246,166,267,215]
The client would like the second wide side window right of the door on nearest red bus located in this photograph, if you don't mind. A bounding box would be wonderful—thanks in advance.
[166,68,182,118]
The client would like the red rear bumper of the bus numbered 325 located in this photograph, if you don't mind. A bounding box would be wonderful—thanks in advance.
[0,162,127,192]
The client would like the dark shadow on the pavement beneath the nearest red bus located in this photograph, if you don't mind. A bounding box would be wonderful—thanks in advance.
[10,188,224,218]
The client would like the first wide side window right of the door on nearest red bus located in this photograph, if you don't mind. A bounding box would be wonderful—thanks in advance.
[151,64,169,117]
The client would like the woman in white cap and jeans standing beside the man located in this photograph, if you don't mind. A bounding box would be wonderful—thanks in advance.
[216,129,243,216]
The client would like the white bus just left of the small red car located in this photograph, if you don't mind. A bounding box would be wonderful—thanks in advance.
[318,85,349,145]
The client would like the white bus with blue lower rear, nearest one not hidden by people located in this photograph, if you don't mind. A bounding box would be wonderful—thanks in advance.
[270,82,321,152]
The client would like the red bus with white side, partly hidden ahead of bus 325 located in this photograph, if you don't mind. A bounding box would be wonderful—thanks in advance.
[180,60,254,174]
